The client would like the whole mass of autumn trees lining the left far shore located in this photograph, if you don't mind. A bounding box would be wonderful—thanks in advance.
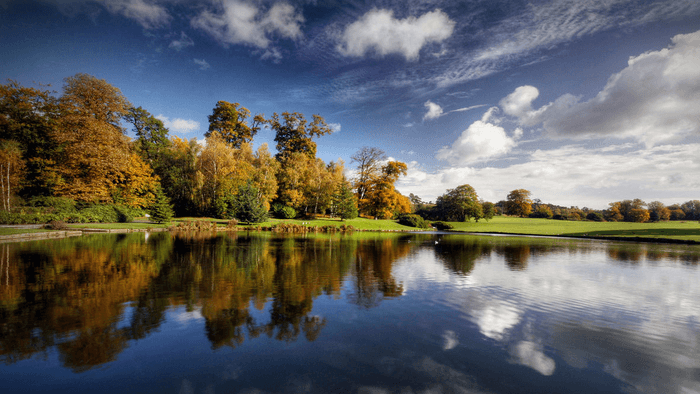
[0,74,418,222]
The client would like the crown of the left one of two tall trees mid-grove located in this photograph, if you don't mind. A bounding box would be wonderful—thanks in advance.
[204,101,265,148]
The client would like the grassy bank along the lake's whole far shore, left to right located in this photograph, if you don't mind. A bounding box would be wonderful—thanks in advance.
[0,216,700,244]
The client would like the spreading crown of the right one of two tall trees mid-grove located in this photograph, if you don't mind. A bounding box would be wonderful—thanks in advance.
[266,112,332,163]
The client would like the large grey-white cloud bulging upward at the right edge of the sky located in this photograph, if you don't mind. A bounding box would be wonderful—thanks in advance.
[520,31,700,146]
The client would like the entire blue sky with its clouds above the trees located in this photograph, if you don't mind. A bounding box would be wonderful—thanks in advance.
[0,0,700,208]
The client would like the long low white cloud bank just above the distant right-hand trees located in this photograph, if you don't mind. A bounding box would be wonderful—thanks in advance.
[397,143,700,209]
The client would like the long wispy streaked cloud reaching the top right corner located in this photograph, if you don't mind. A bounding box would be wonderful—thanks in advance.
[433,0,700,87]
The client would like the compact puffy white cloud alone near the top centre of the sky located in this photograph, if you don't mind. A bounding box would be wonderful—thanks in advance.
[337,9,455,61]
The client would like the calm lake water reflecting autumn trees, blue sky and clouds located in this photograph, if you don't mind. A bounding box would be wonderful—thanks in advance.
[0,233,700,394]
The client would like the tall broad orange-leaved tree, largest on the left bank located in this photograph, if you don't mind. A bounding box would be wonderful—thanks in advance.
[56,74,131,202]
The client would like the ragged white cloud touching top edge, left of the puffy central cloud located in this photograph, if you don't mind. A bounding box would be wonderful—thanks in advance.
[191,0,304,50]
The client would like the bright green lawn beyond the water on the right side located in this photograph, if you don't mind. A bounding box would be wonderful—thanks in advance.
[450,216,700,242]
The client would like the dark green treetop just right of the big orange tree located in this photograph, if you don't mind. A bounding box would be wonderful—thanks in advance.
[124,107,170,169]
